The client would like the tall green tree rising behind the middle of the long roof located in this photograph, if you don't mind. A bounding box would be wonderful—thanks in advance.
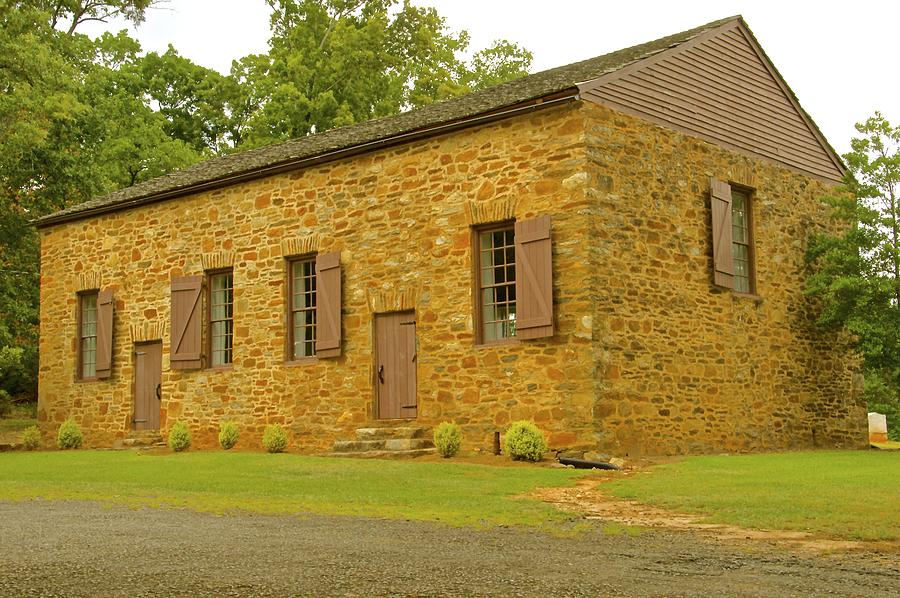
[239,0,531,146]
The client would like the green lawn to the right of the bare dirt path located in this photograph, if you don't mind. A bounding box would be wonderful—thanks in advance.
[603,451,900,541]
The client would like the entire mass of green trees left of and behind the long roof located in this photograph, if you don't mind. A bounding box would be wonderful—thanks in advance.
[0,0,531,404]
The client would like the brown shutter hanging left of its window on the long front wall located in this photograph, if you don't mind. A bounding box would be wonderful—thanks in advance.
[169,276,203,370]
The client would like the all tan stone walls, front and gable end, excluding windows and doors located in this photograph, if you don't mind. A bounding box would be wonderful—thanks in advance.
[38,103,865,455]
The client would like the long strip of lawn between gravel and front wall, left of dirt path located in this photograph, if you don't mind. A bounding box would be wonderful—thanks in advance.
[0,451,582,531]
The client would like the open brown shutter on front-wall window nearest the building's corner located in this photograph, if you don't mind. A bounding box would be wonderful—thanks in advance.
[516,216,553,339]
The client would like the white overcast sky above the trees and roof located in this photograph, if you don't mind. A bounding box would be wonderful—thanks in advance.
[80,0,900,153]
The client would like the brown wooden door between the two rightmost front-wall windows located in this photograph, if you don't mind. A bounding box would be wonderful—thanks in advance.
[375,311,416,419]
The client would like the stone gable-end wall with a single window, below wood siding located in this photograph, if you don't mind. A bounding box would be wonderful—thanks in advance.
[585,105,866,454]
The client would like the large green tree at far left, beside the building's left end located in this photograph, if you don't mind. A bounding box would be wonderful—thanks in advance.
[0,0,199,404]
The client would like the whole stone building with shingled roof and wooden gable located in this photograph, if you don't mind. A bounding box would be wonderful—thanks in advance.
[36,17,866,455]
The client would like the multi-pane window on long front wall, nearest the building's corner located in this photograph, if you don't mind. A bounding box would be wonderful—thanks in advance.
[476,224,516,343]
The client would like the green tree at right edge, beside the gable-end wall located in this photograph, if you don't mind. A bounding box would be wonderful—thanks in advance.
[806,112,900,439]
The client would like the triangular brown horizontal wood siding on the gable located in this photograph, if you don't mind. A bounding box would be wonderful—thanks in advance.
[581,21,843,181]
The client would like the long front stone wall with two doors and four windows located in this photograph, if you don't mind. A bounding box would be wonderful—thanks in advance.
[39,103,594,451]
